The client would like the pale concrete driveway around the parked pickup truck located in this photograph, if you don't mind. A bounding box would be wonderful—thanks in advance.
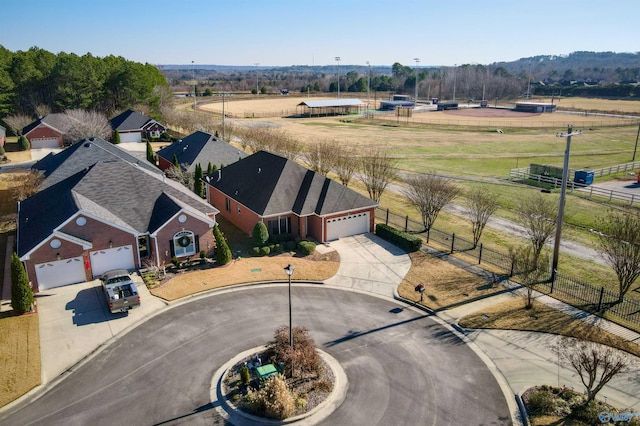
[36,274,166,384]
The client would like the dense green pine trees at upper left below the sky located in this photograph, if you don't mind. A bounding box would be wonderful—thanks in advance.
[0,45,168,118]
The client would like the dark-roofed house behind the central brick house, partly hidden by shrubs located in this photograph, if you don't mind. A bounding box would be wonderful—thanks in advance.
[156,131,247,173]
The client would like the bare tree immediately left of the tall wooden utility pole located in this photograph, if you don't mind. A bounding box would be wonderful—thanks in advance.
[518,193,557,258]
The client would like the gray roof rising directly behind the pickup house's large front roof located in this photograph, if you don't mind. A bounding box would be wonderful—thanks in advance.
[32,138,162,189]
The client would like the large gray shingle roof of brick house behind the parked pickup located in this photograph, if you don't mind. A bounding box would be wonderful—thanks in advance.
[18,161,218,256]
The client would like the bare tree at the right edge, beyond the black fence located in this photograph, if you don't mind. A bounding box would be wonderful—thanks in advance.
[598,212,640,301]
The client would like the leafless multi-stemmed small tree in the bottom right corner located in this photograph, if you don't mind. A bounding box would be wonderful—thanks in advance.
[553,337,636,404]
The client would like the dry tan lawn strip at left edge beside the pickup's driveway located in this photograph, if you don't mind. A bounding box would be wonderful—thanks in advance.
[0,312,40,407]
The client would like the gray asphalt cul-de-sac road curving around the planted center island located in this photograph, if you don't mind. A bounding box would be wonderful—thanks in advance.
[0,285,511,425]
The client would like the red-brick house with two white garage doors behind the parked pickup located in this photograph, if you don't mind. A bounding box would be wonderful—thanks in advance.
[17,140,218,291]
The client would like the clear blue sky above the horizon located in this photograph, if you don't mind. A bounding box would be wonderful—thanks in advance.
[0,0,640,67]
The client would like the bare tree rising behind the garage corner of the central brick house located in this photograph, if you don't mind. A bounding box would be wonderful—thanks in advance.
[358,148,398,203]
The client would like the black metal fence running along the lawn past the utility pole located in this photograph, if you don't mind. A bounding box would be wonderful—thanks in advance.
[376,207,640,326]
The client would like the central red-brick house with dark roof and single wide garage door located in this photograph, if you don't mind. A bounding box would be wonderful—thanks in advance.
[204,151,377,243]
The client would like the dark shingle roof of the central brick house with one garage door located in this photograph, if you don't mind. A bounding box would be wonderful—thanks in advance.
[205,151,377,216]
